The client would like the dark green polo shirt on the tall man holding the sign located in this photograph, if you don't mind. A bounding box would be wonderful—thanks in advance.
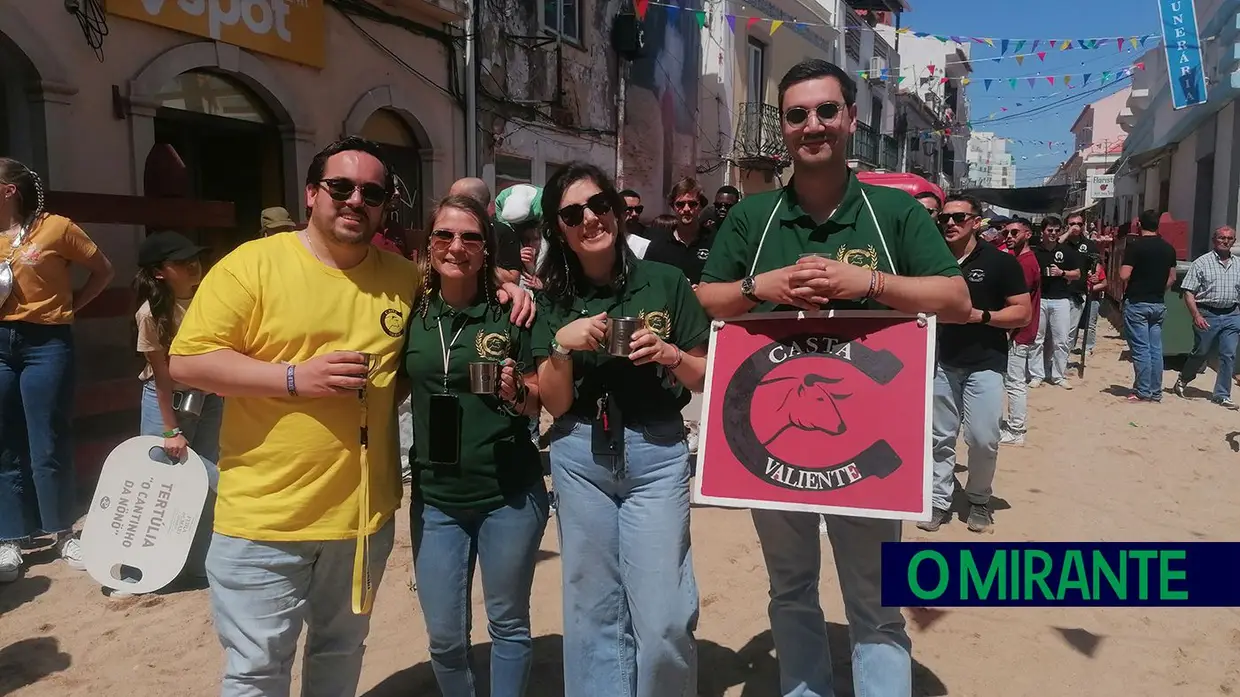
[702,172,960,313]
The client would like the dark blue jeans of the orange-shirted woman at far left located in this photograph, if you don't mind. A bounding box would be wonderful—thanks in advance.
[0,321,76,542]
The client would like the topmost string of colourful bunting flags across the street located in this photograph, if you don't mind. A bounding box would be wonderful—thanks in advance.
[635,0,1162,48]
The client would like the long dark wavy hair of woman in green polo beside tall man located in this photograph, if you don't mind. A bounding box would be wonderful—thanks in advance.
[538,161,634,305]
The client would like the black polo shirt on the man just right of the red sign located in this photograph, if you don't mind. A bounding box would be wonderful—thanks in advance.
[939,241,1029,372]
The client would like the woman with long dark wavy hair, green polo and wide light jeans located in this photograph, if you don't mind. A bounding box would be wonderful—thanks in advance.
[533,164,711,697]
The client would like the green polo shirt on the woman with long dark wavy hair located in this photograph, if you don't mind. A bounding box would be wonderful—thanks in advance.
[533,259,711,425]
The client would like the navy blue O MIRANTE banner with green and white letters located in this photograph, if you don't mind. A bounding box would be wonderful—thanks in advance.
[883,542,1240,608]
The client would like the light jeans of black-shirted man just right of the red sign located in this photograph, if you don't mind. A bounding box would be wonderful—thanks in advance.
[931,365,1003,511]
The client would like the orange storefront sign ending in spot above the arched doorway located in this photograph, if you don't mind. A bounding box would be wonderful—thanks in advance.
[107,0,325,68]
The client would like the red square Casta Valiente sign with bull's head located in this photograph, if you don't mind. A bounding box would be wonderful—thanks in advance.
[693,311,935,520]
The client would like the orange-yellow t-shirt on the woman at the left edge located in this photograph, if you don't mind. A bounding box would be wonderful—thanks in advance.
[0,215,98,325]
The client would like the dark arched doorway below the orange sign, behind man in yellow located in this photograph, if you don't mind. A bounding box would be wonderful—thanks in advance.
[146,69,285,258]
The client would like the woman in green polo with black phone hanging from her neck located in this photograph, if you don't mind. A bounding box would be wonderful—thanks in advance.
[404,196,548,697]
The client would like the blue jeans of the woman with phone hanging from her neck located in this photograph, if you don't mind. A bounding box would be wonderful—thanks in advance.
[409,480,548,697]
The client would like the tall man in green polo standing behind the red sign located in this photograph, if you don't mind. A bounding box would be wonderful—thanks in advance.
[697,60,972,697]
